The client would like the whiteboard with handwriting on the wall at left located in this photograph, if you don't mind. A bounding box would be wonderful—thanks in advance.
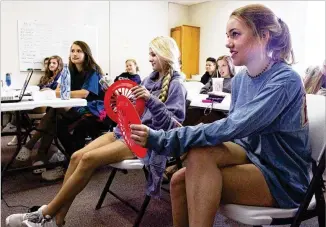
[18,20,98,71]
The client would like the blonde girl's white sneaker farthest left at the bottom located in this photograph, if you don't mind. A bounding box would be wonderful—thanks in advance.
[6,205,46,227]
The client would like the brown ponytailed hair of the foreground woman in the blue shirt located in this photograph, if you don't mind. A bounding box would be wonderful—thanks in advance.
[230,4,295,64]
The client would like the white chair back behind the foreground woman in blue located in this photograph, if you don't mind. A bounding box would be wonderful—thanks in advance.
[306,94,326,163]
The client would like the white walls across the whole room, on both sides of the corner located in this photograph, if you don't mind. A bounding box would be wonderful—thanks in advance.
[0,1,325,86]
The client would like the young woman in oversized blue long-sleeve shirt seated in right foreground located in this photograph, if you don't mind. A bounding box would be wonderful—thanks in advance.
[131,4,311,227]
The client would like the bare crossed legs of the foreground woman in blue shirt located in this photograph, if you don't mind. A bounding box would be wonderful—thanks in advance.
[171,142,275,227]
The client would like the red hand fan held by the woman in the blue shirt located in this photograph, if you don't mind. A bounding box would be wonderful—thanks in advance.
[117,95,147,158]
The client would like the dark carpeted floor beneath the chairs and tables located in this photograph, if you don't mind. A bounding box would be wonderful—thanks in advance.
[1,137,318,227]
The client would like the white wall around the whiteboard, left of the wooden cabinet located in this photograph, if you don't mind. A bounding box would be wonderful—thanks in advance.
[0,1,171,87]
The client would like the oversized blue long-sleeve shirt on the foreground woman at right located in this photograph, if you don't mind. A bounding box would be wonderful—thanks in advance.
[147,62,311,208]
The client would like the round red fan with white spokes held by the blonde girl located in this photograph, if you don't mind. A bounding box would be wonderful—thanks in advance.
[104,80,145,123]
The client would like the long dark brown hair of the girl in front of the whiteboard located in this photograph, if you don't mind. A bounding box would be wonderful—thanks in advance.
[69,41,103,76]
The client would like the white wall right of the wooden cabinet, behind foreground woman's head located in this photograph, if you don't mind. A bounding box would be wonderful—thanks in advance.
[189,1,325,75]
